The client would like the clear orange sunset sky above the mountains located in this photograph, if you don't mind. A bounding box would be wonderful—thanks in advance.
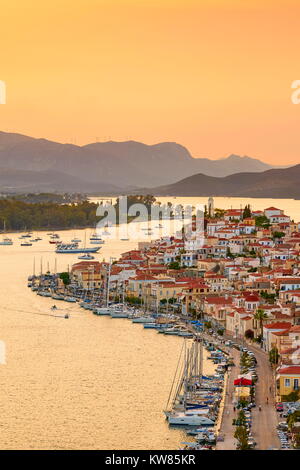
[0,0,300,164]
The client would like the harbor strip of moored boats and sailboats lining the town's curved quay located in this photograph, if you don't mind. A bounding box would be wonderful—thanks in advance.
[28,264,232,450]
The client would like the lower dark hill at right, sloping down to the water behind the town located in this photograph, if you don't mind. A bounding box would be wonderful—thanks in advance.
[140,165,300,199]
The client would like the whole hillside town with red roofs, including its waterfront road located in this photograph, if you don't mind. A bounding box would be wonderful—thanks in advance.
[30,198,300,449]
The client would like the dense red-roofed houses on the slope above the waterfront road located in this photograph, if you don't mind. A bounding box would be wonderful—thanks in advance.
[72,205,300,396]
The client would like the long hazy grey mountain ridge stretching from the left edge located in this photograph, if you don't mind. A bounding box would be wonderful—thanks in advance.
[0,132,282,192]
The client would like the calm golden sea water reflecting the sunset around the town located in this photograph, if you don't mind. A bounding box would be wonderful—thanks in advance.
[0,198,300,450]
